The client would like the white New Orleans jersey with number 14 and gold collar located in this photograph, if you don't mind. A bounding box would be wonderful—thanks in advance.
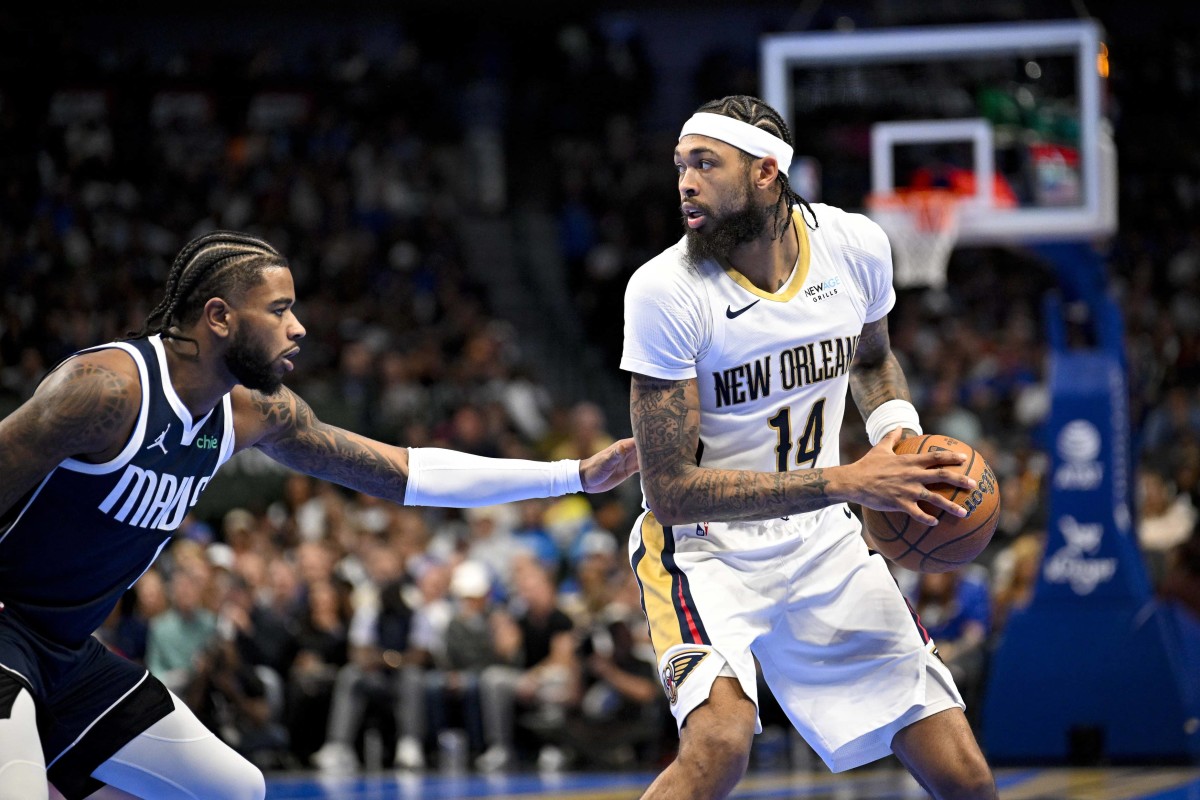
[620,204,895,549]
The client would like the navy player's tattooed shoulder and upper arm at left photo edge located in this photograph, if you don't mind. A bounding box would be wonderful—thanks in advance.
[0,349,142,515]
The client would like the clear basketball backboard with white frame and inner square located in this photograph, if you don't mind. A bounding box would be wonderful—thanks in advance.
[760,19,1116,245]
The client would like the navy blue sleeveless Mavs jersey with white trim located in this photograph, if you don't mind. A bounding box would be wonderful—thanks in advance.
[0,336,234,644]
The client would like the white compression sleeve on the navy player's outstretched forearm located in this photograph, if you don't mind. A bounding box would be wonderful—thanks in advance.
[404,447,583,509]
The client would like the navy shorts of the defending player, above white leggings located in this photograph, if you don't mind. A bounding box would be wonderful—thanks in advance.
[0,609,174,800]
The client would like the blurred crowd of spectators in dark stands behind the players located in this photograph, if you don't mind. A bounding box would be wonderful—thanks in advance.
[0,2,1200,770]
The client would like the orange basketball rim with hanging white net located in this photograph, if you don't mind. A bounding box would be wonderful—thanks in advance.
[866,190,959,289]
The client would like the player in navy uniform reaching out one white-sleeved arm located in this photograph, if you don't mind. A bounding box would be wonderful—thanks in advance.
[0,231,637,800]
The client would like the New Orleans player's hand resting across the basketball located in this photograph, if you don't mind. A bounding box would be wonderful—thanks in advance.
[854,428,976,525]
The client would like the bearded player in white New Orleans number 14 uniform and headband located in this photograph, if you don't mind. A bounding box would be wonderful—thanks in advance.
[622,96,996,800]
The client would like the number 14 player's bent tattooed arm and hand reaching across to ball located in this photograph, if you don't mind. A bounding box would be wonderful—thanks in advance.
[630,373,970,525]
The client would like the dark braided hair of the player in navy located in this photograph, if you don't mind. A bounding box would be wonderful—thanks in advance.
[126,230,287,348]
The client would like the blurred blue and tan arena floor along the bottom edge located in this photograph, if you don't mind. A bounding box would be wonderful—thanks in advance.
[266,768,1200,800]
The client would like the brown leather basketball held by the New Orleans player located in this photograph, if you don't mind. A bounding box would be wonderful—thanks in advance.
[863,434,1000,572]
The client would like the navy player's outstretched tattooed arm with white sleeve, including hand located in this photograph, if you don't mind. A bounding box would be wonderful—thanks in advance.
[234,386,637,507]
